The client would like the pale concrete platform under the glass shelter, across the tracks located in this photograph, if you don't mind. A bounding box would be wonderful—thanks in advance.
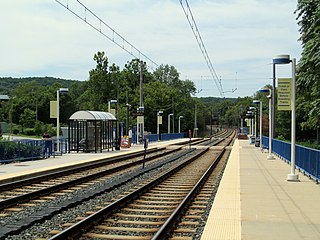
[0,138,188,182]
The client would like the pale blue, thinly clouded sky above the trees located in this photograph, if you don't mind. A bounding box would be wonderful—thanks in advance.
[0,0,302,98]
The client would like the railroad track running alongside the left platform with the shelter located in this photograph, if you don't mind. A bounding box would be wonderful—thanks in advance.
[0,148,181,212]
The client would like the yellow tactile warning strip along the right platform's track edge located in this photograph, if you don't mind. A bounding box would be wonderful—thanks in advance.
[201,139,241,240]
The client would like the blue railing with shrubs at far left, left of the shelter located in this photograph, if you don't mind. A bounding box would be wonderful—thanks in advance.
[0,138,68,163]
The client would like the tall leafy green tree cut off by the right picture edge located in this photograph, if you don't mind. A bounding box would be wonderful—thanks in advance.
[296,0,320,140]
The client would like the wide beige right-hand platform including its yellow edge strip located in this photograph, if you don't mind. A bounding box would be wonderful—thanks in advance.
[201,139,320,240]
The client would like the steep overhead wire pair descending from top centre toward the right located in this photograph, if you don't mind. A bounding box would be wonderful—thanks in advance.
[179,0,224,97]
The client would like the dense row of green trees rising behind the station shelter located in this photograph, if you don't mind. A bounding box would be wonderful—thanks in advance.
[0,52,225,135]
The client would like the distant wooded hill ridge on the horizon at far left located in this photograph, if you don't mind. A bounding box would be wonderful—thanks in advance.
[0,77,79,95]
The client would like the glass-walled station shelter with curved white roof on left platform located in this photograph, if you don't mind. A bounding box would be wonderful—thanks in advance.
[68,111,118,153]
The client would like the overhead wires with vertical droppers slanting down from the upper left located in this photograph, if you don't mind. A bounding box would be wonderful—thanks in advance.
[55,0,159,70]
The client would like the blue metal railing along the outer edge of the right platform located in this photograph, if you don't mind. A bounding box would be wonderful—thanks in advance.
[262,136,320,182]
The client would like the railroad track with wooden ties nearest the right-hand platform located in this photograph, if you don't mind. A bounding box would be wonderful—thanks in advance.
[46,132,232,240]
